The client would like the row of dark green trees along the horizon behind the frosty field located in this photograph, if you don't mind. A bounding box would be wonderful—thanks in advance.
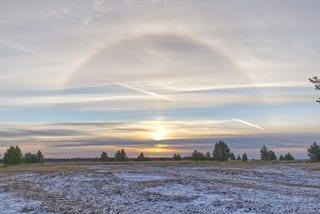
[2,141,320,165]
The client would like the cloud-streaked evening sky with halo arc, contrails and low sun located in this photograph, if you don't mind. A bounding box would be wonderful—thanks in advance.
[0,0,320,158]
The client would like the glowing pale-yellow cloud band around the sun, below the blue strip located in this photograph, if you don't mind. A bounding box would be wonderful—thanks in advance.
[0,119,262,145]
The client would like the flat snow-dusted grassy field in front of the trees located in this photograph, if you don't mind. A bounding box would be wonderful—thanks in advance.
[0,161,320,213]
